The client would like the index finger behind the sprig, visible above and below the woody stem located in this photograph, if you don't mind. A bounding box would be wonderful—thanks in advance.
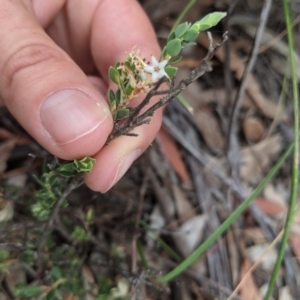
[85,0,161,192]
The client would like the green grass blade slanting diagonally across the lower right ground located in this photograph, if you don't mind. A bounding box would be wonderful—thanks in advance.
[158,142,294,282]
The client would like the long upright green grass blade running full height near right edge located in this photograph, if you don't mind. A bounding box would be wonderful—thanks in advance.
[264,0,299,300]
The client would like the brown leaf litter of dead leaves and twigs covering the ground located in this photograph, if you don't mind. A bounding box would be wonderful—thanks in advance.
[0,0,300,300]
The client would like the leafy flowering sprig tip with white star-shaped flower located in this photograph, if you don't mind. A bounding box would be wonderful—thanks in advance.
[108,12,226,122]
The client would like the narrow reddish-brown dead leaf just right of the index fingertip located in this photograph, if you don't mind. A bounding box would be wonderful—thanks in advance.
[157,127,192,187]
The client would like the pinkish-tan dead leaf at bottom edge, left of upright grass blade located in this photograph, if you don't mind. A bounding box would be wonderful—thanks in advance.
[240,258,262,300]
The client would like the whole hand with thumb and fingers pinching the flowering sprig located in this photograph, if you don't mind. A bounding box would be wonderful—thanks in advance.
[0,0,161,192]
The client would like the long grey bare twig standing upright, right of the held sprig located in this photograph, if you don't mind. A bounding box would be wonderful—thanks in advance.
[227,0,272,183]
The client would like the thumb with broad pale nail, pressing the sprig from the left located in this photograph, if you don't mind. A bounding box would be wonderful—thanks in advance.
[0,0,112,159]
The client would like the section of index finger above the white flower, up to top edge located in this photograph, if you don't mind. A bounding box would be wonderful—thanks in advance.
[91,0,160,81]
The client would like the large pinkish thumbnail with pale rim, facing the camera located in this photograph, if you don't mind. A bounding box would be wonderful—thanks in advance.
[40,90,109,145]
